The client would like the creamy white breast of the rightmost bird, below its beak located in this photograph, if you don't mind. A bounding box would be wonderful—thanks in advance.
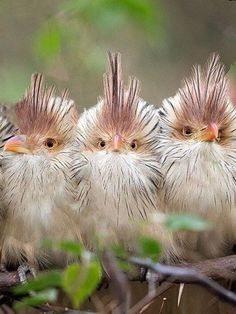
[159,142,236,218]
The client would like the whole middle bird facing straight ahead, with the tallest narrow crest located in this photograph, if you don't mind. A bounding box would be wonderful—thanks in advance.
[73,53,161,246]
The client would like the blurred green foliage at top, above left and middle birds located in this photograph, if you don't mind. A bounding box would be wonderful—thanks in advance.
[33,0,162,66]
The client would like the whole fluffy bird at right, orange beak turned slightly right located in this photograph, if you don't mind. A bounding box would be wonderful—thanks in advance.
[158,54,236,259]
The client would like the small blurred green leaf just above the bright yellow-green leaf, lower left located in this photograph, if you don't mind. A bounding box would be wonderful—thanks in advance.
[43,240,84,257]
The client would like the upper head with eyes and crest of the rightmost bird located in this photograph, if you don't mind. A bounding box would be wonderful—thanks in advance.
[160,54,236,143]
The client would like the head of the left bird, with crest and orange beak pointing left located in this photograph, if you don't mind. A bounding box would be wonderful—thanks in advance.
[4,74,77,157]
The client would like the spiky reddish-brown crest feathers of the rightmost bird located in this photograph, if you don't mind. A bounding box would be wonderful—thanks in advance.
[176,54,229,123]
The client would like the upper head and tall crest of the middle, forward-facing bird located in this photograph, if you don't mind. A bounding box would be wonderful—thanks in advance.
[79,53,159,151]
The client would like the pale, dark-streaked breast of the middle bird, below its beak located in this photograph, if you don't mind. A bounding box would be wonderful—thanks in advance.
[77,151,158,231]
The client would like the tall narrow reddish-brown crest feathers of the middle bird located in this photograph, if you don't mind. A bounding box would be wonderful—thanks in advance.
[102,52,140,132]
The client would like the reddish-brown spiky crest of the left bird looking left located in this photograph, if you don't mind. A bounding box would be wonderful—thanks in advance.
[16,73,77,140]
